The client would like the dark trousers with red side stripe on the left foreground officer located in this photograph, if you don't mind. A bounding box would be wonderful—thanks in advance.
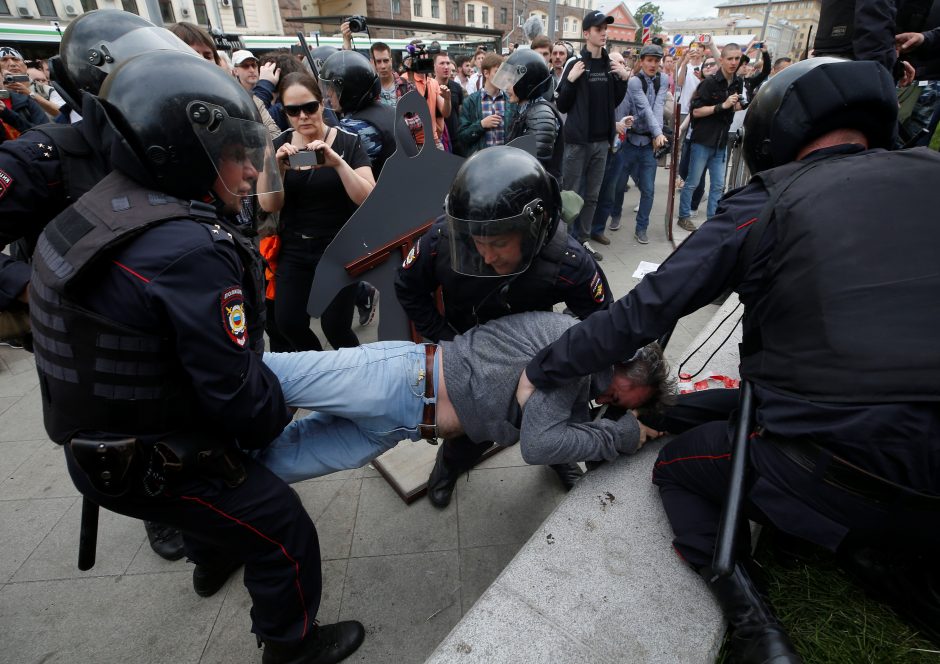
[65,447,322,643]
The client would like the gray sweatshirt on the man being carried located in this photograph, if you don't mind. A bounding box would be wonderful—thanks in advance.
[441,311,640,464]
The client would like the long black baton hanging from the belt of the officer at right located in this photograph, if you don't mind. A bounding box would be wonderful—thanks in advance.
[712,380,754,576]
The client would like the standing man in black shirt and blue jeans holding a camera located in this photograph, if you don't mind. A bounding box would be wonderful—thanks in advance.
[678,43,744,230]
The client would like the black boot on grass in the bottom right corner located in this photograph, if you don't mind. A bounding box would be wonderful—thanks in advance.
[837,547,940,646]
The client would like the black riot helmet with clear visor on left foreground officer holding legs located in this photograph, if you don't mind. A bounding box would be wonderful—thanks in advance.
[98,51,281,202]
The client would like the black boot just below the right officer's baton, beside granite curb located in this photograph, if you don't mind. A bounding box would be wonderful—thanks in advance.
[699,563,803,664]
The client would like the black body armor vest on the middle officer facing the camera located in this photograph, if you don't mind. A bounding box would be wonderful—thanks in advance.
[434,221,578,333]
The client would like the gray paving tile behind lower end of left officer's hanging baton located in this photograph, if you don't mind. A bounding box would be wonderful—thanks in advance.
[11,499,149,582]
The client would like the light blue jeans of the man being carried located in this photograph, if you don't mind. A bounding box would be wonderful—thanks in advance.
[255,341,438,482]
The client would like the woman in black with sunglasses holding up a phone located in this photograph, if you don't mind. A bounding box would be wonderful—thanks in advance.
[260,72,375,350]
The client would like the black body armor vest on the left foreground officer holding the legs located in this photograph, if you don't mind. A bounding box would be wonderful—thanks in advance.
[29,172,264,444]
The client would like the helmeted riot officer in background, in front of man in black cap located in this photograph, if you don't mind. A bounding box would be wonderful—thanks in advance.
[493,49,565,180]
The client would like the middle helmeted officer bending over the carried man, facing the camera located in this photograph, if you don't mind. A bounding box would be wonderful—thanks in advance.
[395,146,612,507]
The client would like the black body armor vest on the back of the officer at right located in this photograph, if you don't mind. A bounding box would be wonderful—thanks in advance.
[741,148,940,403]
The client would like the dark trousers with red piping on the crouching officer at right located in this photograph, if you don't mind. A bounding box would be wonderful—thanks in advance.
[653,422,940,567]
